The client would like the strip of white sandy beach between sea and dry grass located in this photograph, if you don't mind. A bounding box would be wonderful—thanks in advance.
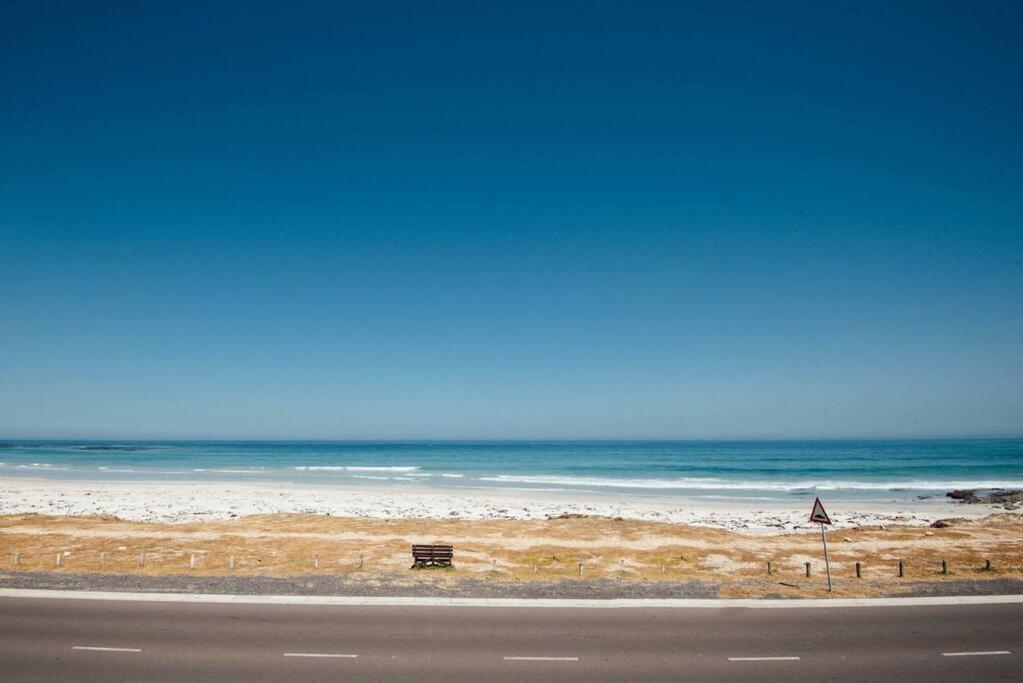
[0,477,1002,534]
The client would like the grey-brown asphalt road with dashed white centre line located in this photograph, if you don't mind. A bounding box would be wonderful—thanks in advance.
[0,598,1023,681]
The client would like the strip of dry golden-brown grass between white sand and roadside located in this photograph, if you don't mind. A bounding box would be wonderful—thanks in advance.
[0,514,1023,596]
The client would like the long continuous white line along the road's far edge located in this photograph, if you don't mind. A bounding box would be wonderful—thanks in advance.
[6,588,1023,609]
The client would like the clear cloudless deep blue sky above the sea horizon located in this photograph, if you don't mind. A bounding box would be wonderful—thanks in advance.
[0,1,1023,439]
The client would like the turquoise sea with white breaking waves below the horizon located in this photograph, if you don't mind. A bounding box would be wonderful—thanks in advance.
[0,439,1023,500]
